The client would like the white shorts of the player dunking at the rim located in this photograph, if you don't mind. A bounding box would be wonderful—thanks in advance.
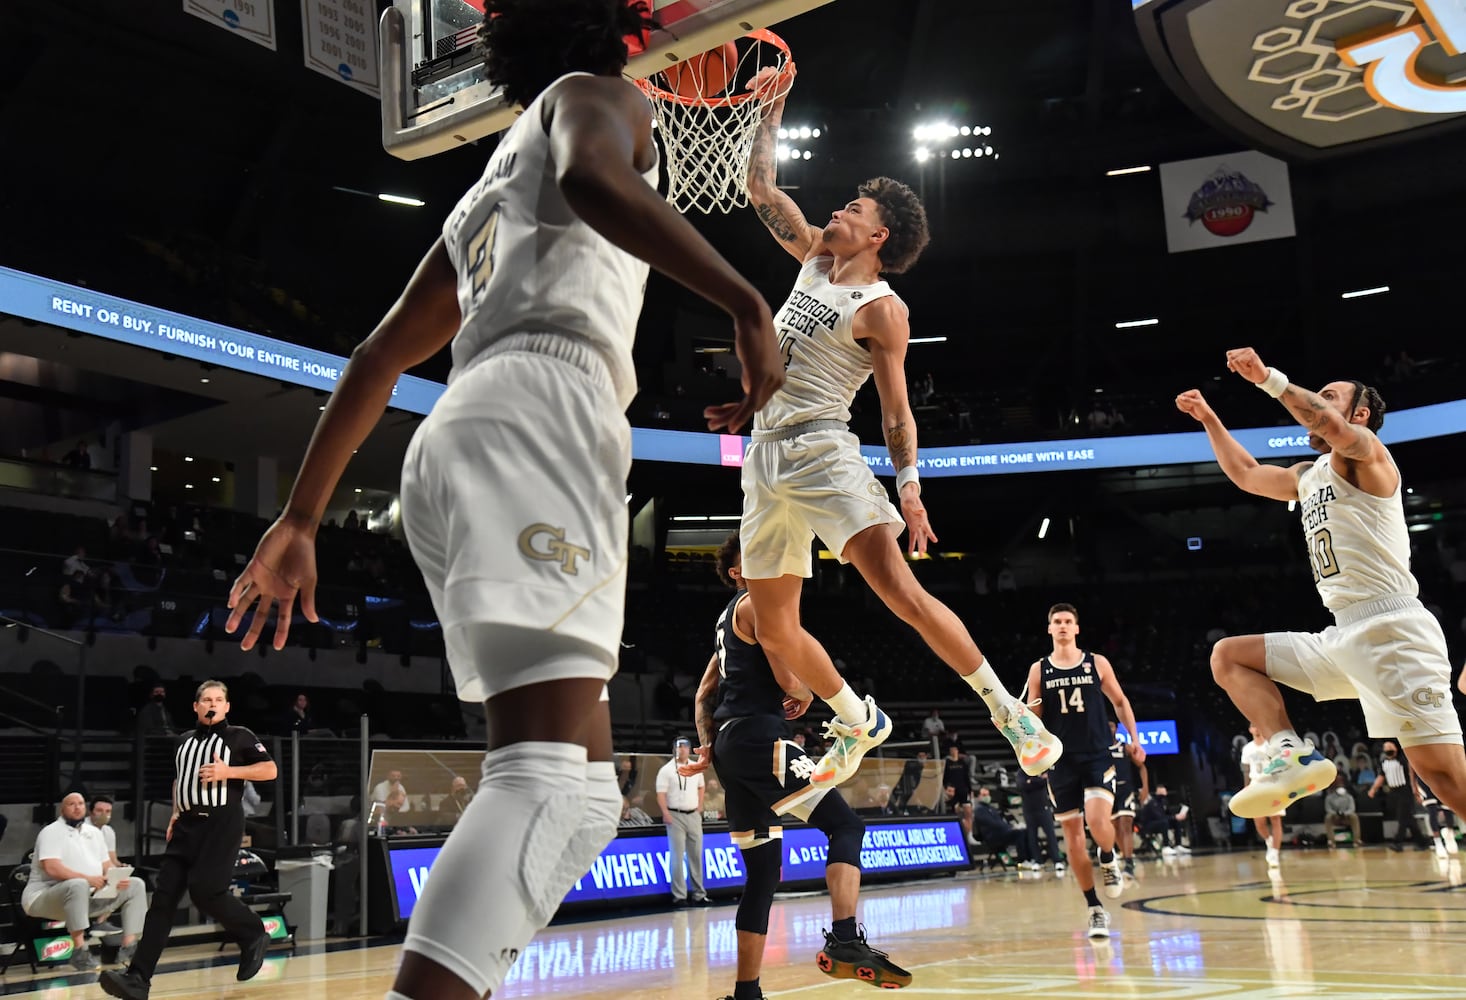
[739,430,906,579]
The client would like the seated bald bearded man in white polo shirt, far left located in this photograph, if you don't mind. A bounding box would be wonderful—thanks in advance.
[21,792,148,971]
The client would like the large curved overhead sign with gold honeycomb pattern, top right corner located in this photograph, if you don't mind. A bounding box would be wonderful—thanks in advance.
[1132,0,1466,160]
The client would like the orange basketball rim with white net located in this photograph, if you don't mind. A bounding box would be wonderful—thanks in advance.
[636,28,795,216]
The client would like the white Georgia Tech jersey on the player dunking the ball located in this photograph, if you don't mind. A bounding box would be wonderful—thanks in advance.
[754,255,905,431]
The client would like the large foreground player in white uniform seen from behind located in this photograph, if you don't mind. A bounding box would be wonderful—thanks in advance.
[219,0,783,1000]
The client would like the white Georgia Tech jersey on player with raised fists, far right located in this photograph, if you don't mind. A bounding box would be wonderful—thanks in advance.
[1297,455,1421,611]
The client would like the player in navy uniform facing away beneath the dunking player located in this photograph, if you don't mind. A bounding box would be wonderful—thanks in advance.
[679,532,912,1000]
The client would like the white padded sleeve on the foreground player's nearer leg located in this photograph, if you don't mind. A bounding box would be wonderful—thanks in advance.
[403,743,586,996]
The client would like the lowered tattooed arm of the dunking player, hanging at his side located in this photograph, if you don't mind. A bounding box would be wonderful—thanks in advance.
[852,298,937,556]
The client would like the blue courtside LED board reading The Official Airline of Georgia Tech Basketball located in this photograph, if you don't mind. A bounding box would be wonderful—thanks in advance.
[387,817,968,919]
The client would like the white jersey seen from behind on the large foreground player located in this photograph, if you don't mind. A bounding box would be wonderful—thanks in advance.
[443,73,657,406]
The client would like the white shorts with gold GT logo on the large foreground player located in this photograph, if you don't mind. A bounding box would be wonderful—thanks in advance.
[402,334,630,701]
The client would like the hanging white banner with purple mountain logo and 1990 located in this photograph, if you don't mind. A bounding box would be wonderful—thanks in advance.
[1161,150,1296,254]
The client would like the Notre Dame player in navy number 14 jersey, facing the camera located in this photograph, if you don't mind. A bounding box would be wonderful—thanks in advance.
[1028,604,1145,937]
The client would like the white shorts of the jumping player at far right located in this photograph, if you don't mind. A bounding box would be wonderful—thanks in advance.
[1264,597,1462,746]
